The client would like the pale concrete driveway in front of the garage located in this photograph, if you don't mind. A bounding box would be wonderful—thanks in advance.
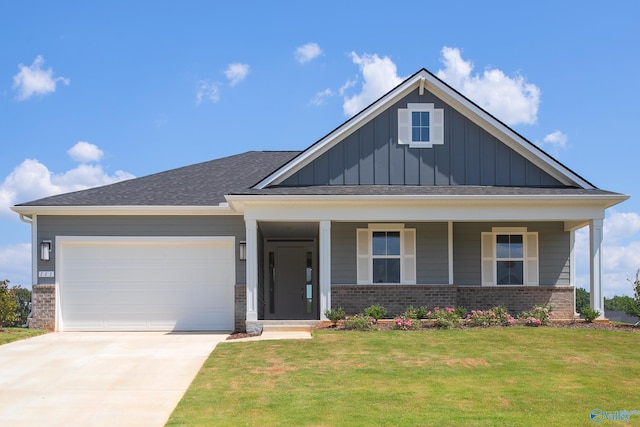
[0,332,227,427]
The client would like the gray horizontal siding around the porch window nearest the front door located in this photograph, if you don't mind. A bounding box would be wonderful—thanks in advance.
[331,222,449,285]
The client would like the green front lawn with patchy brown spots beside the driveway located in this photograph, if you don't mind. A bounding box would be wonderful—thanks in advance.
[167,327,640,426]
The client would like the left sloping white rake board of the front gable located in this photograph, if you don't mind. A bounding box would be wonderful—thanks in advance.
[253,71,424,190]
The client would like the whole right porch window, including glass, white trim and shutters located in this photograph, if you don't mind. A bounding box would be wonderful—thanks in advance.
[482,227,538,286]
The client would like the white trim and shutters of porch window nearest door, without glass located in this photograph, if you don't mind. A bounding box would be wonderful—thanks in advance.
[356,224,416,285]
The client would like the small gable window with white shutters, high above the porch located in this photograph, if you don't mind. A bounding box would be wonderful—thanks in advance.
[398,103,444,148]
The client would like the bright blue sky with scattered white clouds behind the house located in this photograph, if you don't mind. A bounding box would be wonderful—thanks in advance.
[0,0,640,297]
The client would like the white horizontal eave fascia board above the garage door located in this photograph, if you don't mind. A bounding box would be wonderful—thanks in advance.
[11,206,240,217]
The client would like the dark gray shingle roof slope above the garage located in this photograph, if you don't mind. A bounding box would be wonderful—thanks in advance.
[16,151,300,206]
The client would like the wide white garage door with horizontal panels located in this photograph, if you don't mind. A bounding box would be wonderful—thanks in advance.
[56,237,235,331]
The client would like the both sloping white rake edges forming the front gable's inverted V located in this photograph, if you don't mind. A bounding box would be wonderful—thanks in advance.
[254,68,596,189]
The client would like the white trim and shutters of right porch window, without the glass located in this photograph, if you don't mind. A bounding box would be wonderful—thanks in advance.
[480,227,540,287]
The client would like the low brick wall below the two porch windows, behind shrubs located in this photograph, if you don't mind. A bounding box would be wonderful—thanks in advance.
[331,285,574,319]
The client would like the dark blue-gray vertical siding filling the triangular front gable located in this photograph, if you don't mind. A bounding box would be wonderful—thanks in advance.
[280,91,562,187]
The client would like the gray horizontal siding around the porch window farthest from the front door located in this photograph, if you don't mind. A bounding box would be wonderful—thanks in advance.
[453,222,572,286]
